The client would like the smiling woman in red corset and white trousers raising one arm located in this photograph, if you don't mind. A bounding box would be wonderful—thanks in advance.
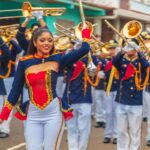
[0,28,90,150]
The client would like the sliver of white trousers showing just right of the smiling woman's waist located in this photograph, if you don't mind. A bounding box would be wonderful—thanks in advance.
[56,76,66,98]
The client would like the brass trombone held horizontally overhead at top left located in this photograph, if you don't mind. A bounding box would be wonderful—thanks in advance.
[0,2,66,19]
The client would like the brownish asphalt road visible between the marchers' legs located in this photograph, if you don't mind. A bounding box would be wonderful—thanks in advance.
[0,118,150,150]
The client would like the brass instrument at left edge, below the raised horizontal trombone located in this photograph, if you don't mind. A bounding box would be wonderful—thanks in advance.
[0,24,19,43]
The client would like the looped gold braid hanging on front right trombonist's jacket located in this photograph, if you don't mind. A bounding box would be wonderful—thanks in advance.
[135,63,150,90]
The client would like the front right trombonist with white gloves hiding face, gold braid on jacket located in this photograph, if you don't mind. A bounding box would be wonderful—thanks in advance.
[113,39,149,150]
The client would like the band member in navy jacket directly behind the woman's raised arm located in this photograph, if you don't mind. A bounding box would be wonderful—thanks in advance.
[63,40,99,150]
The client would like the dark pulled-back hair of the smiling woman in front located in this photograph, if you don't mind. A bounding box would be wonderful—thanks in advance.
[27,27,54,54]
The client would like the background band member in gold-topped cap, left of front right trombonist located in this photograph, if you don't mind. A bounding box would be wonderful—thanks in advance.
[102,40,118,144]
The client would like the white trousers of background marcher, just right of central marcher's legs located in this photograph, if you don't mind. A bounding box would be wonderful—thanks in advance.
[95,89,106,122]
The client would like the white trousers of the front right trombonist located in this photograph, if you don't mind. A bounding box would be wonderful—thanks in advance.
[116,103,142,150]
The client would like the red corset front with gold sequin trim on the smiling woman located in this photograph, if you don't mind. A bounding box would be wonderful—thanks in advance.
[26,70,53,109]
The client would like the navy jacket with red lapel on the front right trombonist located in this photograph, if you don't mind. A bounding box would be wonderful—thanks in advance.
[113,52,149,105]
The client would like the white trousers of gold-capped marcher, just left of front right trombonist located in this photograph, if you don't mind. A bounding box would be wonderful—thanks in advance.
[104,91,117,138]
